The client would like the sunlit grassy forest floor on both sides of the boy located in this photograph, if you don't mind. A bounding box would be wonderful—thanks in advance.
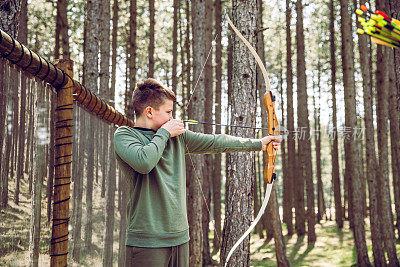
[0,180,400,266]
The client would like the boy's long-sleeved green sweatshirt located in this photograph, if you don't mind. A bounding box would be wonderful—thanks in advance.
[114,126,261,247]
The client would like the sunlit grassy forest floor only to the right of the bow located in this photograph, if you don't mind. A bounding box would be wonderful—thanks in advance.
[250,220,400,266]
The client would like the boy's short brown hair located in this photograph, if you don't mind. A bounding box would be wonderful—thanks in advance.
[132,78,176,118]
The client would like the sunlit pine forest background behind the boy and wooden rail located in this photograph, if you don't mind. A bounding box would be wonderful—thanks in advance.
[0,0,400,266]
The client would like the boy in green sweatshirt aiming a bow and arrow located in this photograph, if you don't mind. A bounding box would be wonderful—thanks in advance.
[114,79,280,266]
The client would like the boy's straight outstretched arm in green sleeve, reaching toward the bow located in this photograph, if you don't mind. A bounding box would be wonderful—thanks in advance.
[182,130,262,154]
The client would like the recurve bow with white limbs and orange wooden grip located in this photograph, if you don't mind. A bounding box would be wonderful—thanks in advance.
[225,12,279,266]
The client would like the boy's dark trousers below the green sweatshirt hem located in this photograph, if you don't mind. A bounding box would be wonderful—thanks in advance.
[125,242,189,267]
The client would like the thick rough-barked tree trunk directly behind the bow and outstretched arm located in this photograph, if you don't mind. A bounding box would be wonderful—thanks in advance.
[221,0,257,266]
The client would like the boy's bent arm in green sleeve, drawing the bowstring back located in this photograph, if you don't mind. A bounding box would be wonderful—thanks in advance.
[114,127,170,174]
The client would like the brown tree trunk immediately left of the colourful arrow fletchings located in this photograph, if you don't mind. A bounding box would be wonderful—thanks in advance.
[340,0,370,266]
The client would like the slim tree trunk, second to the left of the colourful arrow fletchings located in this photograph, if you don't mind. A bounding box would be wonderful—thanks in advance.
[329,0,343,229]
